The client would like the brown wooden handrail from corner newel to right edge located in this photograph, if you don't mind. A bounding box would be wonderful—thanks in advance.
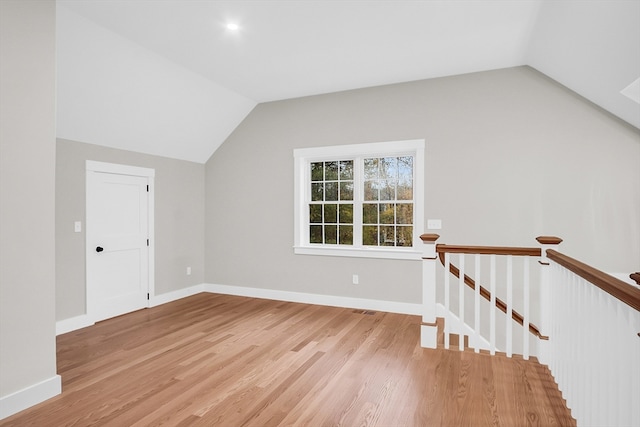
[547,249,640,311]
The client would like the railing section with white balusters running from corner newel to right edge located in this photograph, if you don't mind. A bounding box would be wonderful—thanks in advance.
[539,250,640,426]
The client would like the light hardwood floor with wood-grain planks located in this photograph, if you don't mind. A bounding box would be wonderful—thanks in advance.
[0,293,575,427]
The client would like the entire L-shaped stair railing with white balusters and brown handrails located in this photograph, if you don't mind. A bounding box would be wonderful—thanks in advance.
[421,234,640,426]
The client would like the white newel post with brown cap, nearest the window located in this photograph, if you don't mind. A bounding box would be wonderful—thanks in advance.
[420,234,440,348]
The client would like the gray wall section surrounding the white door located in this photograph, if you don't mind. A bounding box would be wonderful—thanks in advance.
[56,139,205,320]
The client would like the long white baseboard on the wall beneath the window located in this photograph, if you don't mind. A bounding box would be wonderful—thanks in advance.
[204,283,422,315]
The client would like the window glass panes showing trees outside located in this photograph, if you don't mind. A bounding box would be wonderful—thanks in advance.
[309,156,413,247]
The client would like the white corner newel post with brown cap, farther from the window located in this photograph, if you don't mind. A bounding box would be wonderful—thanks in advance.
[536,236,562,365]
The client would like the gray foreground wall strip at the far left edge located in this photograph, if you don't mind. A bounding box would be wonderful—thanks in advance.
[0,0,56,398]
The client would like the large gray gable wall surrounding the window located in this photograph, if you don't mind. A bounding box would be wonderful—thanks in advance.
[205,67,640,303]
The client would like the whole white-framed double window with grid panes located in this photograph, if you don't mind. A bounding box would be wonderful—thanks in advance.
[294,140,424,259]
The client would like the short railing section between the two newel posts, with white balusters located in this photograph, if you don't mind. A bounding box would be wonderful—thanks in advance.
[421,234,562,359]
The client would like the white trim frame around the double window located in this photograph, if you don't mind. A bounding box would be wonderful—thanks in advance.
[293,139,425,260]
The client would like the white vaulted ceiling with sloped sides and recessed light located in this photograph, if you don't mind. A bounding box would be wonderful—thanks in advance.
[57,0,640,163]
